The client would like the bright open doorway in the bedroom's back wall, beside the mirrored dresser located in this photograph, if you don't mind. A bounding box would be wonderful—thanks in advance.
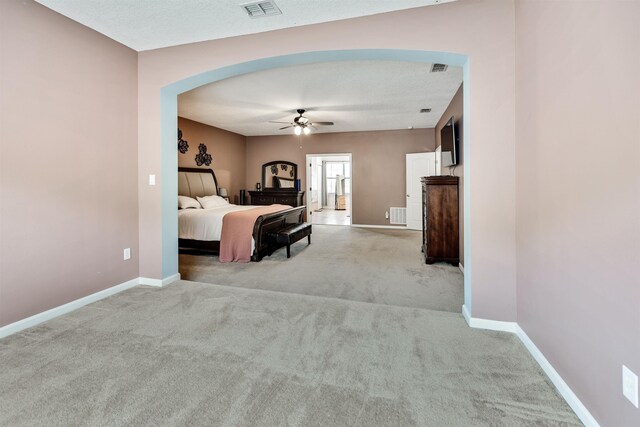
[306,153,353,225]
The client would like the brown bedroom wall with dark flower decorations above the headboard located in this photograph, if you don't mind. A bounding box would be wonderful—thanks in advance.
[178,117,247,202]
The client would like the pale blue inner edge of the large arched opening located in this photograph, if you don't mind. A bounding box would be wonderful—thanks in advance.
[160,49,472,312]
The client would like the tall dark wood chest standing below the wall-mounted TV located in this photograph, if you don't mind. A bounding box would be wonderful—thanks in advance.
[422,176,460,266]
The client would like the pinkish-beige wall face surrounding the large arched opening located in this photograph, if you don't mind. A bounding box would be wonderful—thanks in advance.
[138,0,516,321]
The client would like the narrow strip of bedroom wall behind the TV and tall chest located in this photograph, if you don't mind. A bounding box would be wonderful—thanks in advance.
[435,85,464,265]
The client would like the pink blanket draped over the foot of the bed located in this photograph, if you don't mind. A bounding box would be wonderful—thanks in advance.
[220,205,291,262]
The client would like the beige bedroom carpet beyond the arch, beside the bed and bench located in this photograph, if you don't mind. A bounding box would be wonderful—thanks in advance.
[180,224,464,313]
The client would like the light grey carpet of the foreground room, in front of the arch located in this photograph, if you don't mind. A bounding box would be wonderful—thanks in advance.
[0,281,579,427]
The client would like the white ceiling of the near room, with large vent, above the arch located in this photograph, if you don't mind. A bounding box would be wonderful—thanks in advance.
[36,0,455,51]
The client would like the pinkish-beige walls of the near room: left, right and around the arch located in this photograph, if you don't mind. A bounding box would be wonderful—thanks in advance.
[0,0,640,425]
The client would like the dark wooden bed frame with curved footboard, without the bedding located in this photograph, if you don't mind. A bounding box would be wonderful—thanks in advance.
[178,168,306,261]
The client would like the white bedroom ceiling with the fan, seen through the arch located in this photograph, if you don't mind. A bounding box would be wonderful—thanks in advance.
[178,61,462,136]
